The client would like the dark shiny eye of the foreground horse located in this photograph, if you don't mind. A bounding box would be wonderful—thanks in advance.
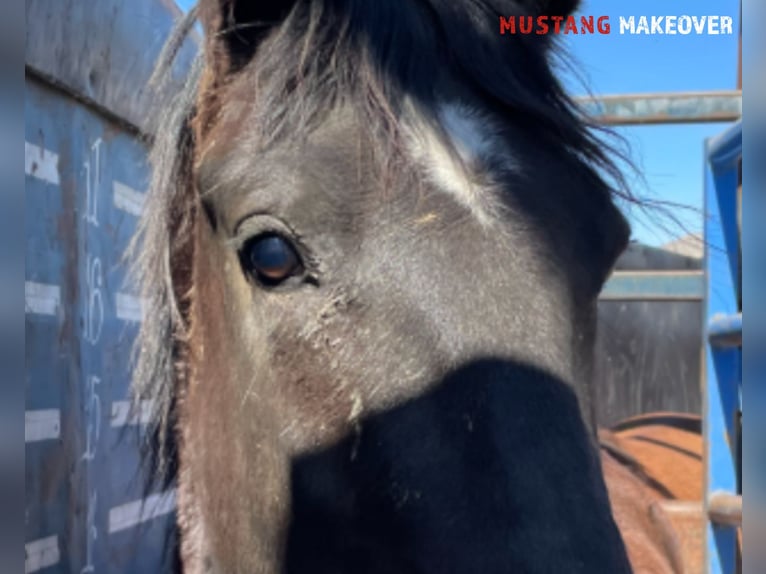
[242,234,303,286]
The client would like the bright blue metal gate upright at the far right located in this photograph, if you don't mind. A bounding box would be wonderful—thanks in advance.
[703,120,742,574]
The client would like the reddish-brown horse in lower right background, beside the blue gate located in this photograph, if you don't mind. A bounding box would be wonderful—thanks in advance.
[599,413,705,574]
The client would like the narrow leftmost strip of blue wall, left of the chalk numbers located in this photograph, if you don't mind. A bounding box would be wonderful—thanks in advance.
[25,79,84,572]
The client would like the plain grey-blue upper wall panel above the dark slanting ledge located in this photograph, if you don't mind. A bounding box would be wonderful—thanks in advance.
[25,0,201,133]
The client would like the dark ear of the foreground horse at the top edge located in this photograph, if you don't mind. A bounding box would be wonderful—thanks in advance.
[197,0,296,74]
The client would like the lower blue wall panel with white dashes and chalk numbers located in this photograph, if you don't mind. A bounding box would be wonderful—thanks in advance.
[25,78,173,573]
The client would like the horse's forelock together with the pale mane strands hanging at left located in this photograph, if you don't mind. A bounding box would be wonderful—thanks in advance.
[133,0,632,496]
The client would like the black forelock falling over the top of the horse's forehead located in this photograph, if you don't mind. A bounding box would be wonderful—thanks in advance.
[195,0,633,189]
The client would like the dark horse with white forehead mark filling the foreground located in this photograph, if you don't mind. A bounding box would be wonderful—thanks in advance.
[133,0,688,574]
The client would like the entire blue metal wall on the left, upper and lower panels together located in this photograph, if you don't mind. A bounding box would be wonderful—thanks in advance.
[25,0,196,573]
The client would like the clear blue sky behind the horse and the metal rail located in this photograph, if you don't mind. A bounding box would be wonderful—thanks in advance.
[178,0,739,245]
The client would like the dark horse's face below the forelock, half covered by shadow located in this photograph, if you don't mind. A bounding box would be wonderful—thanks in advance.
[158,0,636,572]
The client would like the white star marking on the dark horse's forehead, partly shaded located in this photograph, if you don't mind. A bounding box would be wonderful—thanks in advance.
[409,104,503,224]
